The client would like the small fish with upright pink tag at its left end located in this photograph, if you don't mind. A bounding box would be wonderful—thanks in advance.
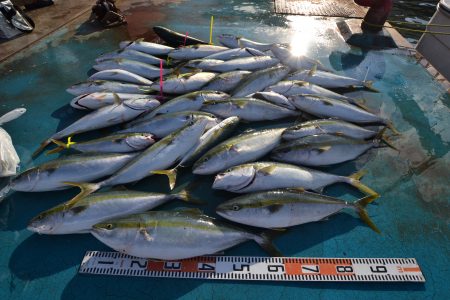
[151,72,216,94]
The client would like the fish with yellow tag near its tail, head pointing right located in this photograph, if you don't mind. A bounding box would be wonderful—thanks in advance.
[47,132,155,154]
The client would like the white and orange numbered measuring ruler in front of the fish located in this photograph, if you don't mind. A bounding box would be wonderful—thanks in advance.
[79,251,425,282]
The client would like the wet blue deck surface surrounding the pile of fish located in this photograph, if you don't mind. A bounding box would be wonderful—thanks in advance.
[0,0,450,299]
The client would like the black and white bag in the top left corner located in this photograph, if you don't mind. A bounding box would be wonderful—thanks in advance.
[0,0,34,39]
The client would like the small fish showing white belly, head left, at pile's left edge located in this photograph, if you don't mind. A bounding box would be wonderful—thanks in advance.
[70,92,156,110]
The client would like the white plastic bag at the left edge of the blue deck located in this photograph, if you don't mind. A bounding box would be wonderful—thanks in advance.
[0,108,26,177]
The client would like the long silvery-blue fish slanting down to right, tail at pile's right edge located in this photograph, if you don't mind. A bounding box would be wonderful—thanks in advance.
[288,95,398,134]
